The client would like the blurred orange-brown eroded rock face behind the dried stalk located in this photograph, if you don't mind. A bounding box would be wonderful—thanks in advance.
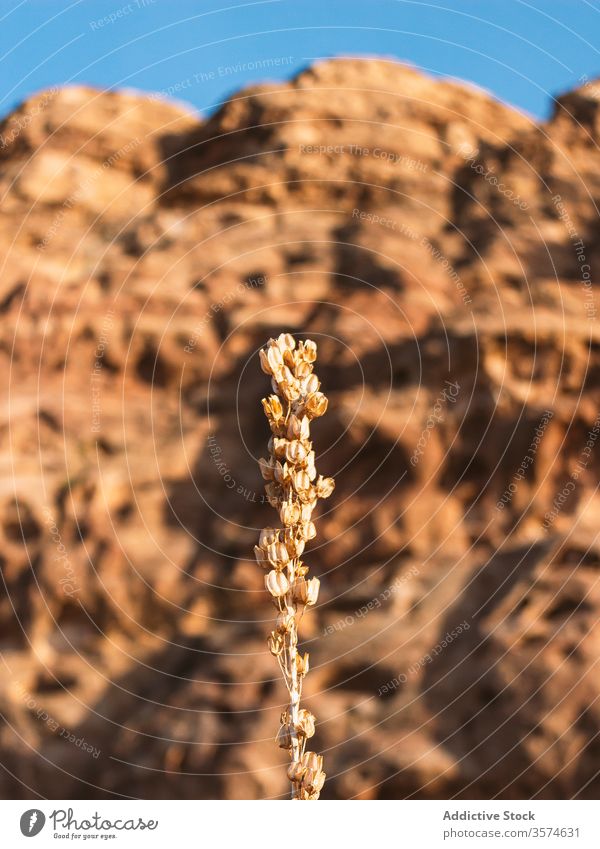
[0,60,600,798]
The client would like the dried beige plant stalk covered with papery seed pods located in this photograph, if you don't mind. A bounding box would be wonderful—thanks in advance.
[254,333,335,799]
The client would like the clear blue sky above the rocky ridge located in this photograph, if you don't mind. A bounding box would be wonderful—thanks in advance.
[0,0,600,116]
